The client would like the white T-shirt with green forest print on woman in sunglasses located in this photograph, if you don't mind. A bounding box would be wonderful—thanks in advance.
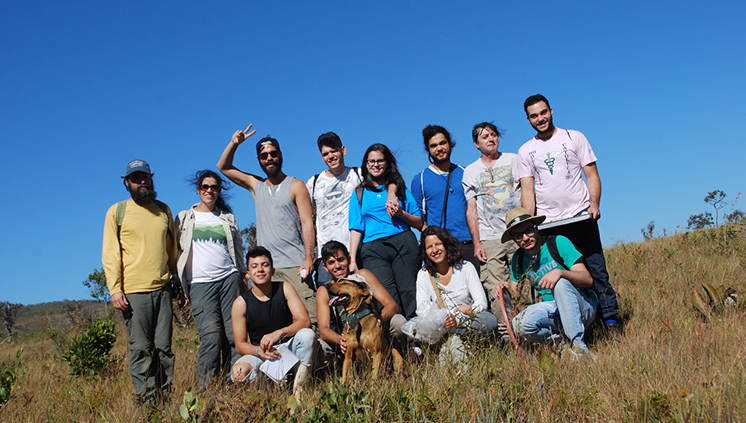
[186,210,237,283]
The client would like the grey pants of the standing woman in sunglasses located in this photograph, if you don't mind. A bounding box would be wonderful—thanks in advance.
[189,272,241,388]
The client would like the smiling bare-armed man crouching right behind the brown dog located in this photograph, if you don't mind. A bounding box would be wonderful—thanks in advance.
[316,241,407,361]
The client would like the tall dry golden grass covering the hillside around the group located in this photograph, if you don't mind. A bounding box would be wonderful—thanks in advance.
[0,226,746,422]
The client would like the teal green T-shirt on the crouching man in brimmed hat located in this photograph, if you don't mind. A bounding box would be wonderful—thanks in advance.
[510,235,598,301]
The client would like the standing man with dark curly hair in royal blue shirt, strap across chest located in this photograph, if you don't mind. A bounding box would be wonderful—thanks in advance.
[410,125,482,274]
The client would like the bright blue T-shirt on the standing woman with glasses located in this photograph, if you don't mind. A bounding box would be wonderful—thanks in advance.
[350,185,422,243]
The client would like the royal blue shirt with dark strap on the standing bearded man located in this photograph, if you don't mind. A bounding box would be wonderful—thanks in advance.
[411,164,471,241]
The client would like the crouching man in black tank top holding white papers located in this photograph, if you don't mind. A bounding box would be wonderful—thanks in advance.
[231,246,316,397]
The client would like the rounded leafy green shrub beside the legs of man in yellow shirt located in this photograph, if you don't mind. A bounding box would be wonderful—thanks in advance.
[62,318,117,378]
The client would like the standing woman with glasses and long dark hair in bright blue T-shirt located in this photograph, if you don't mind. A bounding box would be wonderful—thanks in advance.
[350,144,422,319]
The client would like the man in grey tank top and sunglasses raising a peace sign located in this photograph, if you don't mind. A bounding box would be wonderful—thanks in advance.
[218,125,316,323]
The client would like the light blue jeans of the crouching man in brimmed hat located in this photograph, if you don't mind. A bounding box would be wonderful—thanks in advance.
[513,278,598,350]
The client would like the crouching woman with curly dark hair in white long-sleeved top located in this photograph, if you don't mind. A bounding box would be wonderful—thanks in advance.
[417,226,497,362]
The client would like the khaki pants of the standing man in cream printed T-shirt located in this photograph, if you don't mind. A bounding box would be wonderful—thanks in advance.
[480,239,518,335]
